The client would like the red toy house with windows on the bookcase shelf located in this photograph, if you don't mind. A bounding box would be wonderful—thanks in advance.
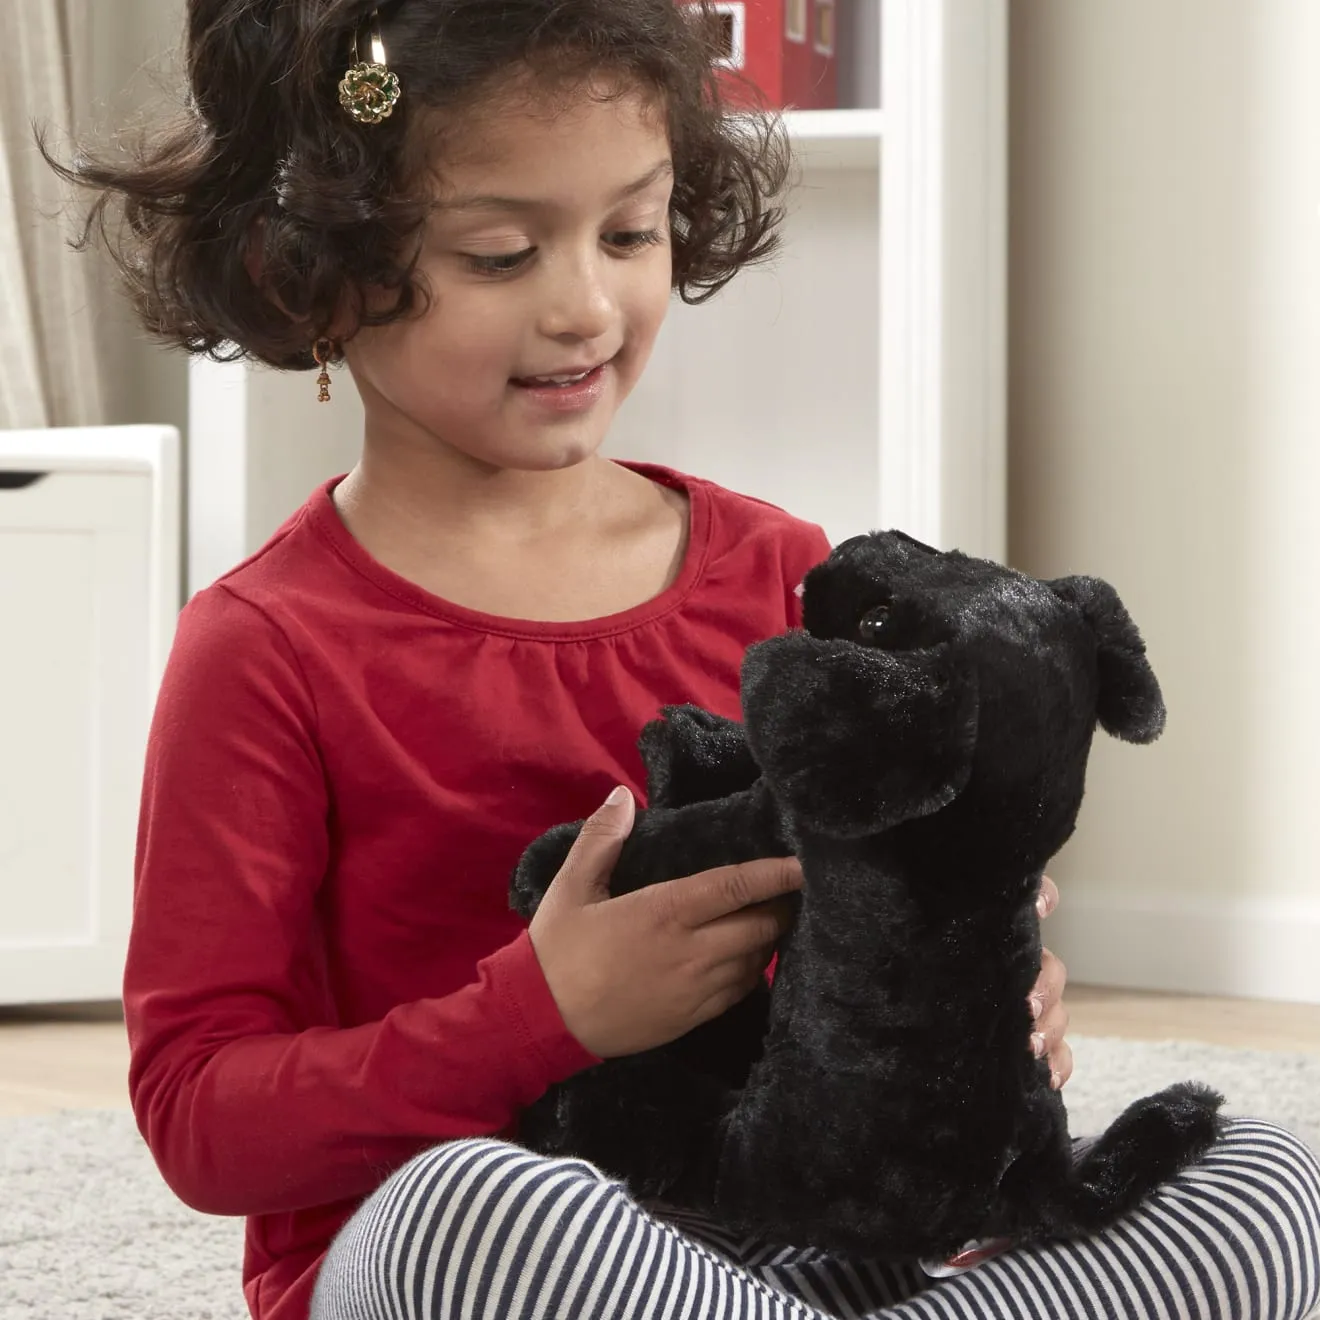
[678,0,838,110]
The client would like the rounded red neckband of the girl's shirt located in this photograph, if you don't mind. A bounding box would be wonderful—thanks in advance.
[308,461,711,642]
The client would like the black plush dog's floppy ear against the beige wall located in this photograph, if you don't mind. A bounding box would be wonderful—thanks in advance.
[1047,577,1164,743]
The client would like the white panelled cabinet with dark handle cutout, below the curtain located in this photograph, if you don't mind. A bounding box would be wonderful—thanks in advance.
[0,426,180,1003]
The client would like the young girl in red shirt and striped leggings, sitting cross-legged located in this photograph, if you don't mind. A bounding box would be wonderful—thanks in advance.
[64,0,1320,1320]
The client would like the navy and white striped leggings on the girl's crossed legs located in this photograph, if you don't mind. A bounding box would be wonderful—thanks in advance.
[312,1119,1320,1320]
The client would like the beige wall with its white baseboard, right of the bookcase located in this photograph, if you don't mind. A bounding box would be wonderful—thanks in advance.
[1010,0,1320,1002]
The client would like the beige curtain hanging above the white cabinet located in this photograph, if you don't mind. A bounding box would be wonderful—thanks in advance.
[0,0,108,428]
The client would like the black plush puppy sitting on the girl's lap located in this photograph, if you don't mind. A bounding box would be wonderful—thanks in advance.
[512,533,1221,1259]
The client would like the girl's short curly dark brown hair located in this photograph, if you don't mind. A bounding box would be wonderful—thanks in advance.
[42,0,791,368]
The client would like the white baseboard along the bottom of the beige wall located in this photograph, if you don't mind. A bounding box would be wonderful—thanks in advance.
[1043,891,1320,1005]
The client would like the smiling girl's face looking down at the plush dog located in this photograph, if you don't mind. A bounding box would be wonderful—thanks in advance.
[345,81,673,471]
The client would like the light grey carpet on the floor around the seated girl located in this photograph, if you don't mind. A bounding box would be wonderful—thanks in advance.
[0,1038,1320,1320]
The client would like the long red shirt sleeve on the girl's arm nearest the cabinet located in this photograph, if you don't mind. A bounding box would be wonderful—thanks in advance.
[124,586,598,1214]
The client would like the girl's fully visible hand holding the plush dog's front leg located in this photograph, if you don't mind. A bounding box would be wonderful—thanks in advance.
[529,789,803,1059]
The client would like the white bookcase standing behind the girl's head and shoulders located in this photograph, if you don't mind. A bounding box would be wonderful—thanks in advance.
[189,0,1007,589]
